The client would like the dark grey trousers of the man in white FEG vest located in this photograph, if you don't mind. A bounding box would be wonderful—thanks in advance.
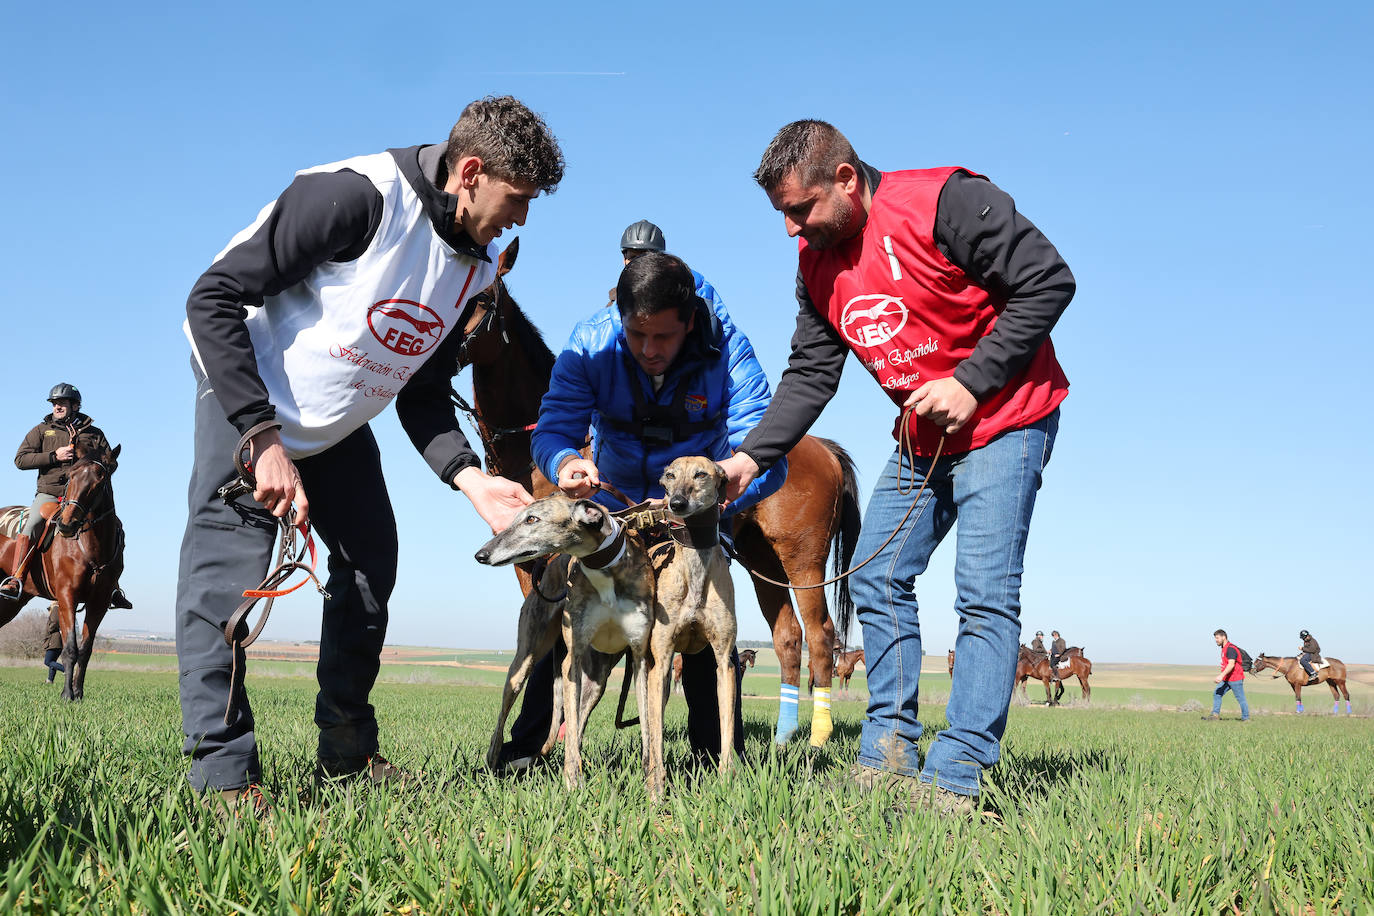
[176,368,397,791]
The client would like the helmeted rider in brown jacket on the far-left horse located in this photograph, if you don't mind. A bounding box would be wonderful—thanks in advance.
[0,382,133,608]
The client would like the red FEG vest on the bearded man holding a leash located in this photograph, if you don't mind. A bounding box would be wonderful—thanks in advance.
[798,168,1069,456]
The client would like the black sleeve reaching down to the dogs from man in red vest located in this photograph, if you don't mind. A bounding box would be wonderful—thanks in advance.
[739,271,849,471]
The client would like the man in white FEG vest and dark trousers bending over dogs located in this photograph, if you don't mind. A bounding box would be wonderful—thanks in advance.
[176,96,563,809]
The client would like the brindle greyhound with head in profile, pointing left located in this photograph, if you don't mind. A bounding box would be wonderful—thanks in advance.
[477,493,654,787]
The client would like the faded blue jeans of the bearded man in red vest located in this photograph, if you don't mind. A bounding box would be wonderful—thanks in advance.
[851,409,1059,795]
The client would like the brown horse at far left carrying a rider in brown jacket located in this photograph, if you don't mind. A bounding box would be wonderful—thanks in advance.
[0,445,124,700]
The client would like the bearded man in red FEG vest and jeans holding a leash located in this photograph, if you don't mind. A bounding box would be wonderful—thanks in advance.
[721,121,1074,812]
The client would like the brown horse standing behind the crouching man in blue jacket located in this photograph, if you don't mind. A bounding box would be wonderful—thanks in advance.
[458,240,859,746]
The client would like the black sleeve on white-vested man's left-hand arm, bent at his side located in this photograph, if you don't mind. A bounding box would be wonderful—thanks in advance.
[185,169,382,433]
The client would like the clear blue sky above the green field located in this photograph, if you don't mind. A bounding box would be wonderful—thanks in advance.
[0,1,1374,662]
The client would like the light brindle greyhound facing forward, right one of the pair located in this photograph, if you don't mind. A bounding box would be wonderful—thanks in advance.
[640,457,736,795]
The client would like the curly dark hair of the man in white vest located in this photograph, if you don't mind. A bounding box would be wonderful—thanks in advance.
[444,95,566,194]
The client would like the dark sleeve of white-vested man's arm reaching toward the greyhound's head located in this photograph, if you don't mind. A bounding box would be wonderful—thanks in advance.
[396,328,482,490]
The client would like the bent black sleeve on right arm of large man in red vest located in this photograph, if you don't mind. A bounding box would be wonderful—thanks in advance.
[934,172,1074,401]
